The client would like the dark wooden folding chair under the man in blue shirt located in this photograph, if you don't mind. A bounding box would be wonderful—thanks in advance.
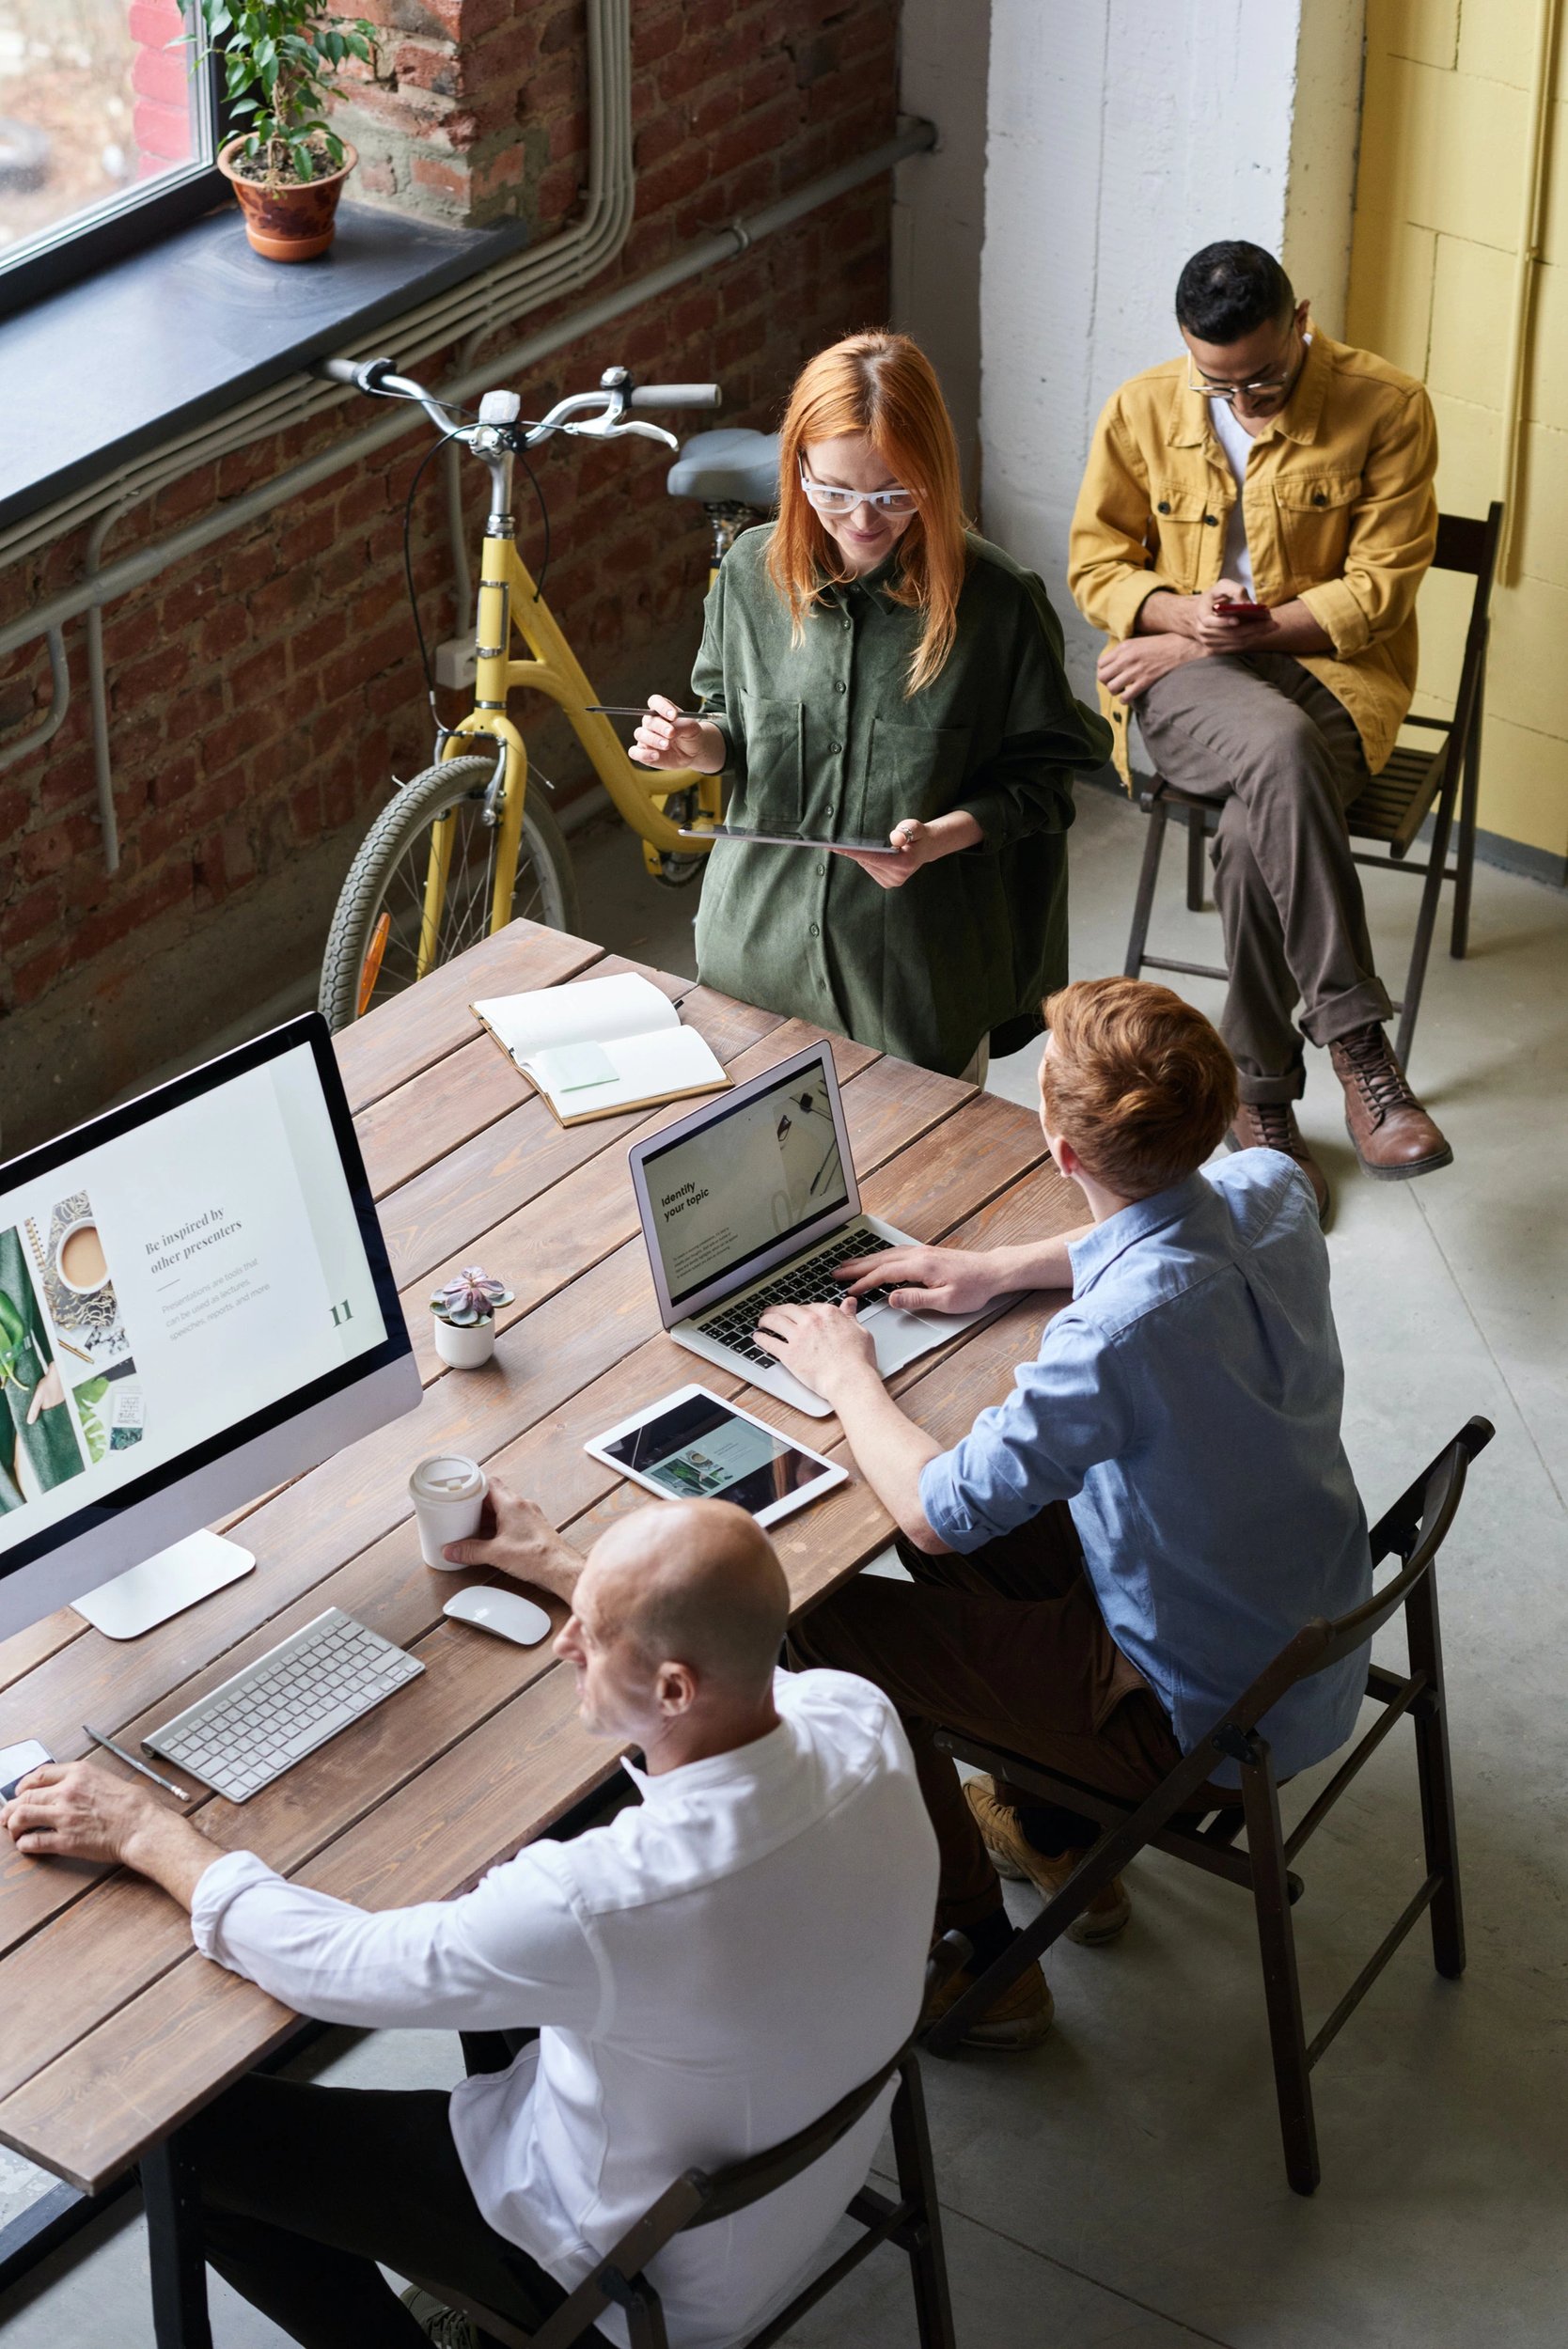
[924,1418,1495,2194]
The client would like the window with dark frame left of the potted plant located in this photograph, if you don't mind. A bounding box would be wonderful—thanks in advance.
[0,0,224,312]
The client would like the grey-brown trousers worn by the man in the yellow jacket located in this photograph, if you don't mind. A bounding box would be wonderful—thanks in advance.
[1137,653,1391,1102]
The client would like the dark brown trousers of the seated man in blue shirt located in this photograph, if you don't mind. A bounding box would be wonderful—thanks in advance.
[790,1501,1180,1931]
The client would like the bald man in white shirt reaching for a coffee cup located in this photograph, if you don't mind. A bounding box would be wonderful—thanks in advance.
[0,1480,935,2349]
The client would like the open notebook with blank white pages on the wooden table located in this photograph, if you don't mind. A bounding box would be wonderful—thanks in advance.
[468,970,731,1125]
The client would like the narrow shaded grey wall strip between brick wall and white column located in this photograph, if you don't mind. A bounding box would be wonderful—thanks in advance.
[893,0,992,505]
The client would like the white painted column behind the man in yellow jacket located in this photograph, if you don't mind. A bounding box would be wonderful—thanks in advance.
[980,0,1363,691]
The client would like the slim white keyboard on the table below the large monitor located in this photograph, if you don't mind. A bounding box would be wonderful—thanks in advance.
[141,1606,423,1802]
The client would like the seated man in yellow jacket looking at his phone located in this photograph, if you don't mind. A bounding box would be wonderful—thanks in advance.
[1067,242,1452,1212]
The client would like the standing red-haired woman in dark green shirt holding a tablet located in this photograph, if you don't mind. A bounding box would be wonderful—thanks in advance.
[633,334,1109,1076]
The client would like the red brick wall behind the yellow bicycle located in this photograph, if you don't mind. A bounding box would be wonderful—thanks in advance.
[0,0,898,1151]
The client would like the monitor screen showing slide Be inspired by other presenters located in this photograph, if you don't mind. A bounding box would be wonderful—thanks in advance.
[0,1045,385,1555]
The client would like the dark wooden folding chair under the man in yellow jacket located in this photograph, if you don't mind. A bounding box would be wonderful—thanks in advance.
[1123,500,1502,1069]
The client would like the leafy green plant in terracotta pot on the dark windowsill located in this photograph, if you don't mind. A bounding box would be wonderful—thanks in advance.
[181,0,376,260]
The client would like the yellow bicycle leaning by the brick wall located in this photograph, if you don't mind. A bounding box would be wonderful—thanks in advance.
[320,359,776,1029]
